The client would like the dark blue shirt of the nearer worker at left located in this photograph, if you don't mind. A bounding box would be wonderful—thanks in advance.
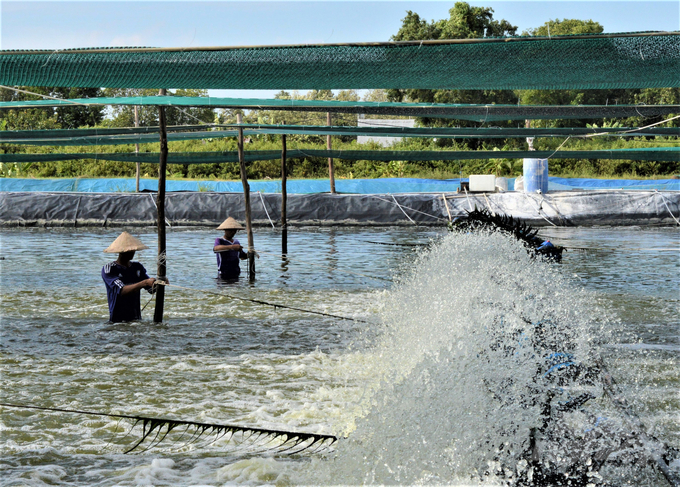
[102,261,151,323]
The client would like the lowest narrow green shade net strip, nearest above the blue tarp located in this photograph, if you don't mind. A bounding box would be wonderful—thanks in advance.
[0,147,680,164]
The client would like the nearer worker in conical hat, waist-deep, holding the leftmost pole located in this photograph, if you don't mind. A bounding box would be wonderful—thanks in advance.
[102,232,168,323]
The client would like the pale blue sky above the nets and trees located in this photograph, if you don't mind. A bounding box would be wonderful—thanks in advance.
[0,0,680,98]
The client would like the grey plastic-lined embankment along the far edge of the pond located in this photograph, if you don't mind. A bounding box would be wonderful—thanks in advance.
[0,190,680,227]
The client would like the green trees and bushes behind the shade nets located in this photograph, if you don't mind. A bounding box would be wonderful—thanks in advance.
[0,2,680,179]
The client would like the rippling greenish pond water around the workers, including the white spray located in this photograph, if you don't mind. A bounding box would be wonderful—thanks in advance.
[0,227,680,486]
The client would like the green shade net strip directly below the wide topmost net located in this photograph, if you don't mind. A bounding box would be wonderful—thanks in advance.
[0,95,680,122]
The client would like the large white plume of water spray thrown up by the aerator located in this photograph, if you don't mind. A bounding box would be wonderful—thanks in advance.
[299,233,664,485]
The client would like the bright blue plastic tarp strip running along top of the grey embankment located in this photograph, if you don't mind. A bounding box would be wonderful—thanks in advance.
[0,177,680,194]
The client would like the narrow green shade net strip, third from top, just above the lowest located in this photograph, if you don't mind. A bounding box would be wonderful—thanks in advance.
[0,125,680,146]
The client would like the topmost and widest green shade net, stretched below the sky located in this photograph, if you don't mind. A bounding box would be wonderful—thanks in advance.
[0,32,680,90]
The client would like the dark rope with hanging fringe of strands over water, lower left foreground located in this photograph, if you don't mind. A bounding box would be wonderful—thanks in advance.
[0,403,338,455]
